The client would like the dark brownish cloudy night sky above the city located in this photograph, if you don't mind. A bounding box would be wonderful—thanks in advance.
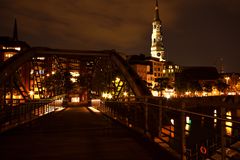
[0,0,240,72]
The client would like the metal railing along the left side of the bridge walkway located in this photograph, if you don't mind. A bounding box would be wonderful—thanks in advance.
[0,95,64,133]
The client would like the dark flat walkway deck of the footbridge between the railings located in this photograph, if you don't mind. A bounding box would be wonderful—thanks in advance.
[0,107,176,160]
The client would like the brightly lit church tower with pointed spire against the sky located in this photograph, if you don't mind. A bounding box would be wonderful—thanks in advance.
[151,0,166,61]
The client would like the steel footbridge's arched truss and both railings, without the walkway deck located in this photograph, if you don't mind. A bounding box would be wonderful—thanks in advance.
[0,47,240,159]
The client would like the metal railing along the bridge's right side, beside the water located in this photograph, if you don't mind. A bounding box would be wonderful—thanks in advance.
[94,97,240,159]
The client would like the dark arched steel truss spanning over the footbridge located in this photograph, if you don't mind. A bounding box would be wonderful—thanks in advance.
[0,48,150,127]
